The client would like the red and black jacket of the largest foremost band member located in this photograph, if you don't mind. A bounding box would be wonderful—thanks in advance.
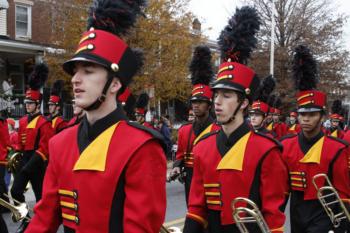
[26,108,166,233]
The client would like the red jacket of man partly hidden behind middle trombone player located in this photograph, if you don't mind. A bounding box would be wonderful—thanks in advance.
[176,123,220,168]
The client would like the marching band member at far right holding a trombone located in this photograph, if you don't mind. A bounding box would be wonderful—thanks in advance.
[282,45,350,233]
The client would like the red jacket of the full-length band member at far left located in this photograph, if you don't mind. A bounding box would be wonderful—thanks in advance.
[17,114,54,160]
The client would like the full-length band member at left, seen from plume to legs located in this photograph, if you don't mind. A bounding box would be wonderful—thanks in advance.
[11,63,54,232]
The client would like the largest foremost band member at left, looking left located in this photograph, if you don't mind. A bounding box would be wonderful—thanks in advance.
[26,0,166,233]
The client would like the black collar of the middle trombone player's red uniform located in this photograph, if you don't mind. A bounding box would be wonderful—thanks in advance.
[216,122,250,156]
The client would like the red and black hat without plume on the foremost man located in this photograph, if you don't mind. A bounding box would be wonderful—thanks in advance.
[63,29,137,85]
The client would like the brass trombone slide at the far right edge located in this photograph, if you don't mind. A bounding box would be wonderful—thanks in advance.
[312,173,350,228]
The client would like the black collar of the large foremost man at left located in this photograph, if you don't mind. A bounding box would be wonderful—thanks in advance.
[78,108,128,153]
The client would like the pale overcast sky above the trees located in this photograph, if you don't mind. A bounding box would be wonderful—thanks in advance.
[190,0,350,50]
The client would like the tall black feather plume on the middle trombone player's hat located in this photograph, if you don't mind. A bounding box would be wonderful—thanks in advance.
[218,6,261,64]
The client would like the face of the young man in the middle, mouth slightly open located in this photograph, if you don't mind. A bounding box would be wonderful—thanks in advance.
[214,89,239,123]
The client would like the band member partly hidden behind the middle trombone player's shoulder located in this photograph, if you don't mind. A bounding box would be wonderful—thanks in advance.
[171,46,219,204]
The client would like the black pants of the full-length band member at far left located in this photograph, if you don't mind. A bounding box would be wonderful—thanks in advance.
[11,151,46,202]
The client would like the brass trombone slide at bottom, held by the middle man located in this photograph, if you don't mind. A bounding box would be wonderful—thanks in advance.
[232,197,271,233]
